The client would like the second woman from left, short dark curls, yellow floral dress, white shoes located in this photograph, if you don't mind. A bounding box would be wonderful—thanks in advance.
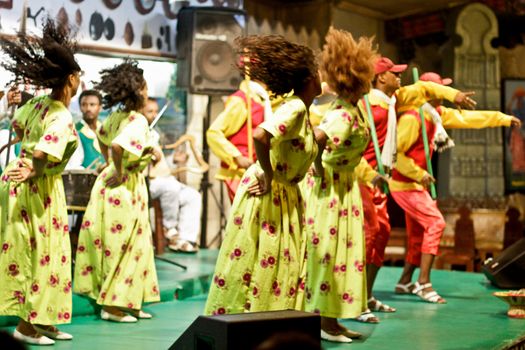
[74,60,159,322]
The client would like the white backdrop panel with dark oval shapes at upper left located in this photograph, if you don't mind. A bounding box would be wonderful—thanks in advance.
[0,0,242,58]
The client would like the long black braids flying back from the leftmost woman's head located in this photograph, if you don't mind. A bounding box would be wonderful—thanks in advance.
[0,17,81,89]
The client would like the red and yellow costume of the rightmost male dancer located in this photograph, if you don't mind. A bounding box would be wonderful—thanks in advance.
[389,82,512,265]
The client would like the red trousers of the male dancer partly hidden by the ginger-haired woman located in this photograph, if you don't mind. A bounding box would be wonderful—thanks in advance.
[359,184,390,267]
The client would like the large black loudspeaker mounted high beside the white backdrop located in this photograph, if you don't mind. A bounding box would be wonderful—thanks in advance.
[176,7,246,95]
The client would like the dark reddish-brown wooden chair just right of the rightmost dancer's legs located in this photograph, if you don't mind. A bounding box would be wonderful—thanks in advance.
[436,207,476,272]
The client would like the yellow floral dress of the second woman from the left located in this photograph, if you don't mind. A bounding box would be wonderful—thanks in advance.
[73,111,160,309]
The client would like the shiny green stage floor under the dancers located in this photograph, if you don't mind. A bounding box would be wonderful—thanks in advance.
[0,250,525,350]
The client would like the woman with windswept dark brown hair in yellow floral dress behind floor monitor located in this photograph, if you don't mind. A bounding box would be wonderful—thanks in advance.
[205,36,321,314]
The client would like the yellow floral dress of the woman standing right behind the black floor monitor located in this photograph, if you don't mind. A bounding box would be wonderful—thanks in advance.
[205,96,317,314]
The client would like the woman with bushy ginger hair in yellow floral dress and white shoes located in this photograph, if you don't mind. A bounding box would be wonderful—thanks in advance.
[305,29,376,342]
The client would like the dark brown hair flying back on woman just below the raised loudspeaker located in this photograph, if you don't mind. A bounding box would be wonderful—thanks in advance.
[235,35,317,95]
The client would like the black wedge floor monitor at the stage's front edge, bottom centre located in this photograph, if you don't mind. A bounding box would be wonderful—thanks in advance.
[170,310,321,350]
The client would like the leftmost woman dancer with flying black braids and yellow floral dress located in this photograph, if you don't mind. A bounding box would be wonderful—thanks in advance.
[0,19,81,345]
